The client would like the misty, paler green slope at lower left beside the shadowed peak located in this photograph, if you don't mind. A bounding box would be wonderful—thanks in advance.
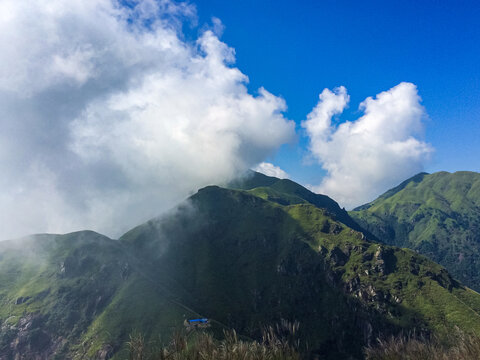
[0,231,202,360]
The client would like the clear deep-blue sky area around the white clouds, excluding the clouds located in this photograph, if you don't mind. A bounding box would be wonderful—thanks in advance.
[194,0,480,183]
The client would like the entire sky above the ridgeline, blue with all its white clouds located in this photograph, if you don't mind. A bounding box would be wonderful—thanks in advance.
[0,0,480,239]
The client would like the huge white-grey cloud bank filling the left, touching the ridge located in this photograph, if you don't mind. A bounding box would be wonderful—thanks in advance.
[0,0,294,239]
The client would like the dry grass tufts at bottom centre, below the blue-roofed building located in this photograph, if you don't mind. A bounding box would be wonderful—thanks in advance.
[127,321,300,360]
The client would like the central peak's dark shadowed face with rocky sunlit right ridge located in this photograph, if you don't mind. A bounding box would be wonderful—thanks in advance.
[121,187,480,357]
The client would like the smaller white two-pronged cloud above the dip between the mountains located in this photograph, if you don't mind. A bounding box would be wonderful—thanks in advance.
[302,83,433,208]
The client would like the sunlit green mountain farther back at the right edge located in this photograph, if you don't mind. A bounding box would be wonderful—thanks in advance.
[350,171,480,291]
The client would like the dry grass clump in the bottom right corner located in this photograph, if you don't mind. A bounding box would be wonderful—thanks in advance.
[365,331,480,360]
